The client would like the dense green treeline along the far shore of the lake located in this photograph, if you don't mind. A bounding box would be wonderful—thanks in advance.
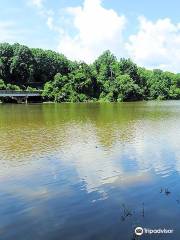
[0,43,180,102]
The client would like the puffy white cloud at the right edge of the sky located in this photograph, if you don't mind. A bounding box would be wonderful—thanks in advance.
[126,17,180,72]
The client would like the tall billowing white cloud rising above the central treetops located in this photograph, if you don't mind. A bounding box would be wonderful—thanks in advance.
[58,0,126,62]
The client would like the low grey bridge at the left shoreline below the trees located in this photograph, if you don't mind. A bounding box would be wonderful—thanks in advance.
[0,90,41,103]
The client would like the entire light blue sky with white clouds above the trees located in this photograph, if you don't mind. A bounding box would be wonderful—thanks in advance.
[0,0,180,72]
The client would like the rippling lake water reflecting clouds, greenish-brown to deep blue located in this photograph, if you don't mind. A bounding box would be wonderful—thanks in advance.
[0,101,180,240]
